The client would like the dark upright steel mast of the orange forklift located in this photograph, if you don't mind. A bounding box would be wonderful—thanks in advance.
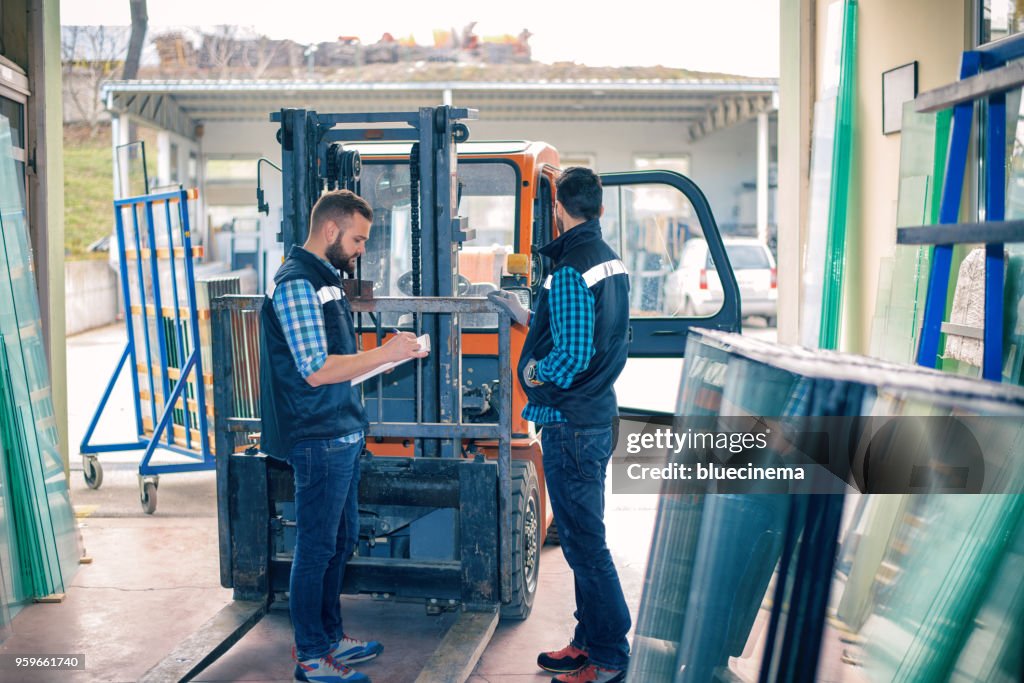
[270,106,476,458]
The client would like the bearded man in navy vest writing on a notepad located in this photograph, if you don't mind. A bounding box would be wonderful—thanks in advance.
[260,189,427,683]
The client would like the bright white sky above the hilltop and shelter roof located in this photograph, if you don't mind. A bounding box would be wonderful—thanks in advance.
[60,0,779,77]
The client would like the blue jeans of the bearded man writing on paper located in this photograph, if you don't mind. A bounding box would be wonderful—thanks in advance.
[288,439,364,659]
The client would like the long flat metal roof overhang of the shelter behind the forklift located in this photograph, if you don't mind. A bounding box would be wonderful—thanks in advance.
[103,79,778,139]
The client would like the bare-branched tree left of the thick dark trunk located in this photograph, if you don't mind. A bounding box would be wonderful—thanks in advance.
[60,26,128,135]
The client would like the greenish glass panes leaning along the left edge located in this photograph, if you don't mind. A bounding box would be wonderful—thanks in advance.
[0,116,80,625]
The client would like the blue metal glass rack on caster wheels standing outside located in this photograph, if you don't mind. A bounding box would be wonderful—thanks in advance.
[80,189,215,514]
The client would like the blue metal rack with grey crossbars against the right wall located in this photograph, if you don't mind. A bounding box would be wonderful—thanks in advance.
[897,35,1024,382]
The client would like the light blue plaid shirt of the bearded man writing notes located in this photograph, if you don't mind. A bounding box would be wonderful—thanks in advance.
[273,248,362,443]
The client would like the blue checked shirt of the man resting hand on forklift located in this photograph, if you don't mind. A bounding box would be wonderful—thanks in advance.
[522,266,594,425]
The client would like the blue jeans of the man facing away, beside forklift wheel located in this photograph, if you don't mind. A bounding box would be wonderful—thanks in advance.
[541,422,631,670]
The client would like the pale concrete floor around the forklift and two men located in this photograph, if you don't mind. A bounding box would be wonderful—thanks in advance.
[0,326,657,683]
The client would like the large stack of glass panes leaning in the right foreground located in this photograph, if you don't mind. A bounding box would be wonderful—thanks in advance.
[629,332,1024,682]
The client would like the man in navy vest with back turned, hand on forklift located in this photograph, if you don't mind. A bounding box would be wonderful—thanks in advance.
[490,167,630,683]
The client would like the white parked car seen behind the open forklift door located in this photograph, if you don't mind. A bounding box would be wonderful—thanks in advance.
[665,238,778,327]
